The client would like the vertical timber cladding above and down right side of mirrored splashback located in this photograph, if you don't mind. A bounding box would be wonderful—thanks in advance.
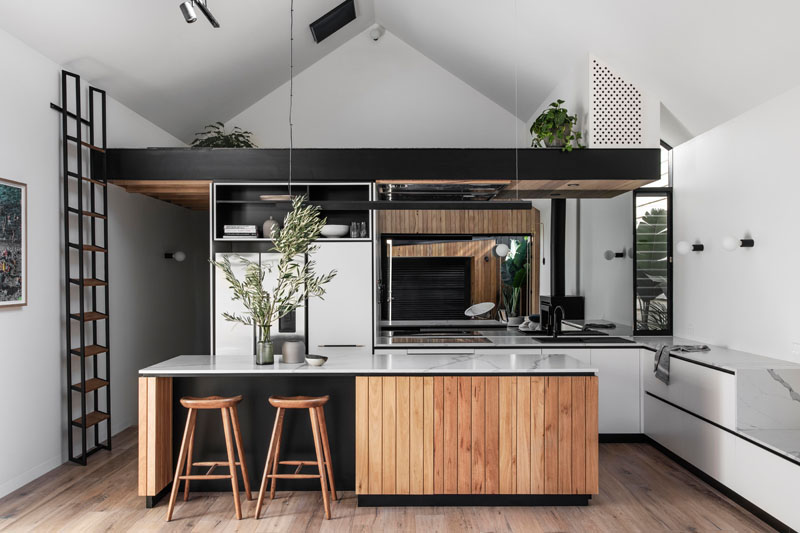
[378,207,542,313]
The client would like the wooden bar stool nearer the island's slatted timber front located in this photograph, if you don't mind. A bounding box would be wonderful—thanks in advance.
[256,396,336,520]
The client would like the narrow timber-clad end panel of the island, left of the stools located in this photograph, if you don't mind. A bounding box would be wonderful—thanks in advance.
[138,377,172,496]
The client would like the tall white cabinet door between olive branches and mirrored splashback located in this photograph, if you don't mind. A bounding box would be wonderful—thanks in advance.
[308,242,372,355]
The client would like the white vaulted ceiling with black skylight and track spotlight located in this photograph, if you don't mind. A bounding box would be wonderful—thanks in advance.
[0,0,800,140]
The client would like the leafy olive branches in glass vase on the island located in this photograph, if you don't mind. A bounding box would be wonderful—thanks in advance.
[211,196,336,365]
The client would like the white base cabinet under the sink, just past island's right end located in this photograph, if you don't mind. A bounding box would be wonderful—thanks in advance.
[590,348,642,433]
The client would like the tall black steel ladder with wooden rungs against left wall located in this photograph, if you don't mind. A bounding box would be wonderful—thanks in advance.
[50,70,111,465]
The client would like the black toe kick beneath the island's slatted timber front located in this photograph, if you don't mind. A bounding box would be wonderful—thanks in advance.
[358,494,592,507]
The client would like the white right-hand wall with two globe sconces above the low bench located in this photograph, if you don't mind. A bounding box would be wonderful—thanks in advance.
[673,83,800,359]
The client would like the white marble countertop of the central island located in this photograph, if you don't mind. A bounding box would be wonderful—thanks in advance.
[139,353,597,376]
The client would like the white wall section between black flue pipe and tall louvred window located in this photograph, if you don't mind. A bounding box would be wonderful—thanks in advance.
[580,193,633,325]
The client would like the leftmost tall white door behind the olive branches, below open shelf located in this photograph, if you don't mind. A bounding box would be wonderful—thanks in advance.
[214,254,258,355]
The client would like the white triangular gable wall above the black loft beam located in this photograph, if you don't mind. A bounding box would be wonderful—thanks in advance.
[225,31,529,148]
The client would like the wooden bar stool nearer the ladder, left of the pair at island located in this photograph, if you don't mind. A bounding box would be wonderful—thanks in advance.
[167,396,252,522]
